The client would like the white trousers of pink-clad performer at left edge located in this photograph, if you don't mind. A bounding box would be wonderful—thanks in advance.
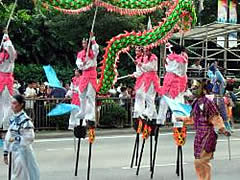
[0,86,13,130]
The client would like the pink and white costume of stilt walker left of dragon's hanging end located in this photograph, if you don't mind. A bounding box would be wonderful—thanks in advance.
[76,40,99,124]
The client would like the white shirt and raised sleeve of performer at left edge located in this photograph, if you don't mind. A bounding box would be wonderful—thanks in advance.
[0,35,17,73]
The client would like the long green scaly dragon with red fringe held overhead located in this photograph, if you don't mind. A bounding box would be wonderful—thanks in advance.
[41,0,197,94]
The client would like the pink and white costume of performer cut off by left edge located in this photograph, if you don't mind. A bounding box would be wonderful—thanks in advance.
[0,34,17,130]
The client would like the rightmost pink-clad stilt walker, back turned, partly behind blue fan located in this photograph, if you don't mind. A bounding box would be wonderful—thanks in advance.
[157,43,188,180]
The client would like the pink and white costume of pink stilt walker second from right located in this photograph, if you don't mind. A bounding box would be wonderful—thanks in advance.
[133,54,159,120]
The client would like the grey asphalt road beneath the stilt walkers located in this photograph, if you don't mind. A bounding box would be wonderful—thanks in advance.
[0,131,240,180]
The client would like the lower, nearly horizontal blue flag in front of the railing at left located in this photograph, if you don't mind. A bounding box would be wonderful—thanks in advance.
[48,103,79,116]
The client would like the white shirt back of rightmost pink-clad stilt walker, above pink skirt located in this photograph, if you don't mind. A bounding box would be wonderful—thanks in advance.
[165,58,188,76]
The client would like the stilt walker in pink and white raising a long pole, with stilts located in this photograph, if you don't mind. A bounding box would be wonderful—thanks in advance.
[74,7,99,180]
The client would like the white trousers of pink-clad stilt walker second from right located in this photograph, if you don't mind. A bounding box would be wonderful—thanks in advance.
[133,83,157,120]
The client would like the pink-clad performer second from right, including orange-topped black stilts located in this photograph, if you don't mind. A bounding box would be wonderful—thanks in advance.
[130,47,160,175]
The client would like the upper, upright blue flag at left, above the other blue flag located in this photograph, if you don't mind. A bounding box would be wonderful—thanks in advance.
[43,65,63,88]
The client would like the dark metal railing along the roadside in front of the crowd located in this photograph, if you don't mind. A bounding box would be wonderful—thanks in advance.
[25,97,134,130]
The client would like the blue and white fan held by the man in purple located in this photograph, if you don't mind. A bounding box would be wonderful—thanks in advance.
[163,96,192,116]
